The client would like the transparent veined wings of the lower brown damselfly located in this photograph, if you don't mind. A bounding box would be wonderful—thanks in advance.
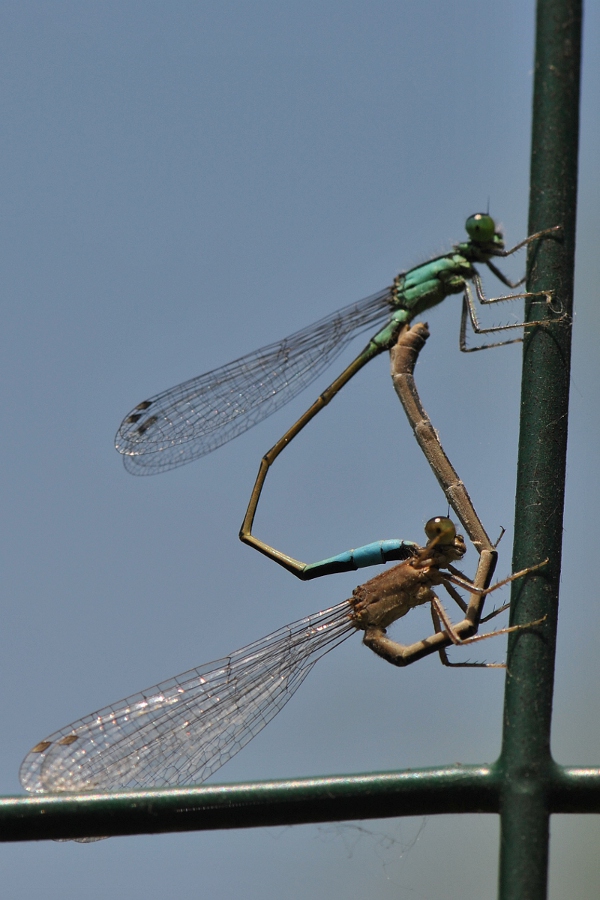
[19,600,355,792]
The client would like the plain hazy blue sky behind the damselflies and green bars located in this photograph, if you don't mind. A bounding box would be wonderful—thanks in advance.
[0,0,600,900]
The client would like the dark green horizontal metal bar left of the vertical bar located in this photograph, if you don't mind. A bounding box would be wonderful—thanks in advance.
[0,765,500,841]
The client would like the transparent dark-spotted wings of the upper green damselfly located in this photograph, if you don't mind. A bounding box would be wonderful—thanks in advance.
[115,288,390,475]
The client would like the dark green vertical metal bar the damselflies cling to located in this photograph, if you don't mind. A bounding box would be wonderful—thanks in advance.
[498,0,582,900]
